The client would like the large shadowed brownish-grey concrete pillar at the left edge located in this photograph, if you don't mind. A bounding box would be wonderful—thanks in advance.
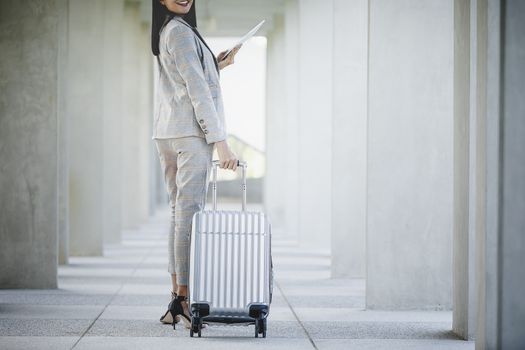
[0,0,67,288]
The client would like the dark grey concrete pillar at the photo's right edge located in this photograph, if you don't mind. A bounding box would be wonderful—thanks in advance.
[476,1,525,349]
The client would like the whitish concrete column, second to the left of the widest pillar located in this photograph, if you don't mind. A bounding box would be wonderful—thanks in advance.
[295,0,333,251]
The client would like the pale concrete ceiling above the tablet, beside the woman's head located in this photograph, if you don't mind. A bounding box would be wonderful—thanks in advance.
[195,0,285,36]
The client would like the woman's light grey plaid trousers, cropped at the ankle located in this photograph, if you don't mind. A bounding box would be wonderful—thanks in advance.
[155,136,213,286]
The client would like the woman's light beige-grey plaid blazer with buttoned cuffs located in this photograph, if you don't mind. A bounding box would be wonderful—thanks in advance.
[152,16,227,144]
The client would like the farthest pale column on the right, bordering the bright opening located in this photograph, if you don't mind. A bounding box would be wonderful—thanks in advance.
[264,0,299,241]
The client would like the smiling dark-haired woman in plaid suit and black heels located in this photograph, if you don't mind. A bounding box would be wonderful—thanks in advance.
[151,0,240,328]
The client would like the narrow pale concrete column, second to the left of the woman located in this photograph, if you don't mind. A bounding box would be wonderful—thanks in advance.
[102,0,124,243]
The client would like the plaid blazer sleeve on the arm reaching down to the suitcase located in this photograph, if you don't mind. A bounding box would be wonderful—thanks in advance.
[167,26,227,144]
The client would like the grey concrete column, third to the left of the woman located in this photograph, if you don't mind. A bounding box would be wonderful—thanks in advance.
[68,0,105,255]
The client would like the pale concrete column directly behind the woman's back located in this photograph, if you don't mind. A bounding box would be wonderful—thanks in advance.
[120,1,153,228]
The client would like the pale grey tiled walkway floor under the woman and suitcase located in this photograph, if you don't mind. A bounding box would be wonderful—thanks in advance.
[0,208,474,350]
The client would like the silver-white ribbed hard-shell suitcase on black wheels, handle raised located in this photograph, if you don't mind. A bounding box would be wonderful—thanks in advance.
[189,161,273,337]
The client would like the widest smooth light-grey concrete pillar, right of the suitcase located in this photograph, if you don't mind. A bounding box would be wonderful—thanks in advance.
[366,0,454,309]
